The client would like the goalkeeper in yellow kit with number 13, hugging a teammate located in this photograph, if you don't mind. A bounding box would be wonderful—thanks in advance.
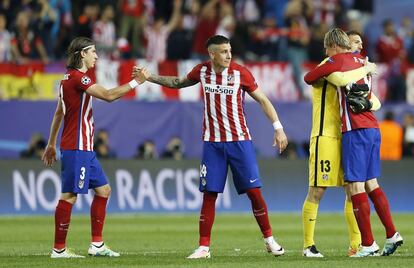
[302,29,381,257]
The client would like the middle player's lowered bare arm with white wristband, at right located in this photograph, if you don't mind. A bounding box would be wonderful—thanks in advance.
[249,89,288,153]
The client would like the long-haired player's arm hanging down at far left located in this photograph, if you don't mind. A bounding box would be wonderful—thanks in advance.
[42,98,64,167]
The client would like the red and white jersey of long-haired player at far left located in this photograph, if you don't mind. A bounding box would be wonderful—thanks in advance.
[59,69,95,151]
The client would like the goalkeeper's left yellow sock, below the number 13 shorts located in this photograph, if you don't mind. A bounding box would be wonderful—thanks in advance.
[302,200,319,248]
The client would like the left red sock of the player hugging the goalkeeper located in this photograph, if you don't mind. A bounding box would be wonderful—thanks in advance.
[351,192,374,246]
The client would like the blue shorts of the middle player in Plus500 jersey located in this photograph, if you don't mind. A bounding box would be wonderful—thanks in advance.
[200,141,262,194]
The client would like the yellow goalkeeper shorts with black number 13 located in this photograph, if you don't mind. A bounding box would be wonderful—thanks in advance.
[309,136,344,187]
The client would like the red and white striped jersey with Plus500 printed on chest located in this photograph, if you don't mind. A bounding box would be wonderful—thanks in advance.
[187,62,257,142]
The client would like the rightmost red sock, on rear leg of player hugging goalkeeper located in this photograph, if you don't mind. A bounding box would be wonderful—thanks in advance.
[369,187,396,238]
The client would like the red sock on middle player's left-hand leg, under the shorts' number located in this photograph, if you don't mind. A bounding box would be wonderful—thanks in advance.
[199,192,217,247]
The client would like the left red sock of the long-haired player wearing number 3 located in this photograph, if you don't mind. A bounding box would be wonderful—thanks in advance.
[53,200,73,249]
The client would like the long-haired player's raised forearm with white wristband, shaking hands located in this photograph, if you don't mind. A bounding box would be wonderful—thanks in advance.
[86,68,150,102]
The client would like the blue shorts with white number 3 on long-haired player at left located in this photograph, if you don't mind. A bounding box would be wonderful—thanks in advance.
[61,150,108,194]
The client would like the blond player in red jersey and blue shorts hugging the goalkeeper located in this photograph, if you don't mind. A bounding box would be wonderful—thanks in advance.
[305,28,403,257]
